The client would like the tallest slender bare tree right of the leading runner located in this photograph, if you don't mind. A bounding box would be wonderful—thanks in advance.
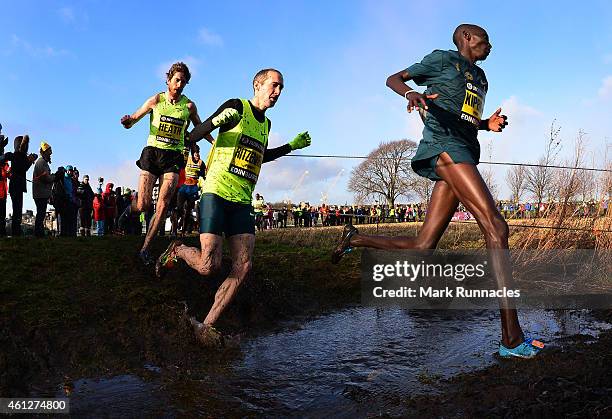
[525,121,561,214]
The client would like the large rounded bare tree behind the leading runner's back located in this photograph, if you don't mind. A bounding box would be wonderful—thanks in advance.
[348,139,416,206]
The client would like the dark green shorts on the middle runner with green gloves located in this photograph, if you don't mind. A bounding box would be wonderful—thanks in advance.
[199,193,255,237]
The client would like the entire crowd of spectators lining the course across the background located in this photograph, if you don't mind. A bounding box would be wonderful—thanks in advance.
[0,133,608,237]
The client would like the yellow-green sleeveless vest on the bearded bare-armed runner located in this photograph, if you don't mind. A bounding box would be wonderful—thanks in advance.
[147,92,189,152]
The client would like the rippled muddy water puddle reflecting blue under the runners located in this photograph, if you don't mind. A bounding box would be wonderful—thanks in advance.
[58,307,610,417]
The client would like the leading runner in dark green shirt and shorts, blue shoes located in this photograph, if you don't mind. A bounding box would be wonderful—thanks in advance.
[332,24,543,358]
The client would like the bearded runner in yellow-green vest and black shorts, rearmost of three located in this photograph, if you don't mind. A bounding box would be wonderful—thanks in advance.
[121,62,212,266]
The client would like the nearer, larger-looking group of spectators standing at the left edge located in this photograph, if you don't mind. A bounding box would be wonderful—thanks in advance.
[0,135,149,237]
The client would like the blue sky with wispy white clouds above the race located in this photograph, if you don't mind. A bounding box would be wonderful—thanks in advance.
[0,0,612,212]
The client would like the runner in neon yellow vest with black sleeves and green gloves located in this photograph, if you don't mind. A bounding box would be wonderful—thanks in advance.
[156,69,311,345]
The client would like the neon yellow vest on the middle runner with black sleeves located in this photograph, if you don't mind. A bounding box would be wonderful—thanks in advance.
[203,99,269,205]
